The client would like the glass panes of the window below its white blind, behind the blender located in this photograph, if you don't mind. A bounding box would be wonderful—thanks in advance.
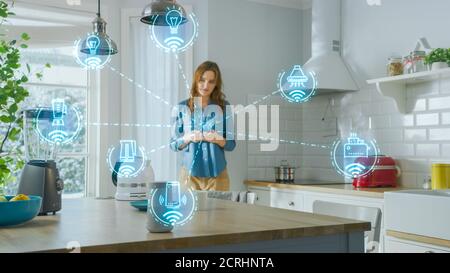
[3,47,89,198]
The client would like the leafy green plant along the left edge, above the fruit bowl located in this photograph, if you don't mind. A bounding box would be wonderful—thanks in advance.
[0,1,50,193]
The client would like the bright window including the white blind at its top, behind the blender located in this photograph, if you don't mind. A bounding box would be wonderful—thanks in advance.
[2,2,95,198]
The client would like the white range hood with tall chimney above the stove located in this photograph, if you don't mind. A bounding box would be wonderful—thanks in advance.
[303,0,359,94]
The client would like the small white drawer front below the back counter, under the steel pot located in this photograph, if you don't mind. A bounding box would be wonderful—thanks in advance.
[270,188,304,211]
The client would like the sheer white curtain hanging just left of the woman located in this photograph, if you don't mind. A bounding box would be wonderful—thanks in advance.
[126,18,187,181]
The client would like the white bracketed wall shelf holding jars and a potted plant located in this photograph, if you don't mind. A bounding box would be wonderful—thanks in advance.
[367,68,450,114]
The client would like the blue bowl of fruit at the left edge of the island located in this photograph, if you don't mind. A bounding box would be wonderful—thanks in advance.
[0,194,42,227]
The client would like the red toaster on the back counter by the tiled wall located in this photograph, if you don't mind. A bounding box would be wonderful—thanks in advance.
[353,155,401,188]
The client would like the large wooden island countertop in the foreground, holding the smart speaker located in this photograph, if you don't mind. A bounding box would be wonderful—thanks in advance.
[0,198,370,252]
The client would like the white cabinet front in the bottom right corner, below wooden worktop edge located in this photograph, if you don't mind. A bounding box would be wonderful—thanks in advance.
[385,236,450,253]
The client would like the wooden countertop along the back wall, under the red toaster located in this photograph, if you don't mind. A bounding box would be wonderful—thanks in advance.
[244,180,410,198]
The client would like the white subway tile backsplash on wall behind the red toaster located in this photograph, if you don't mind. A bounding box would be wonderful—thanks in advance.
[248,82,450,187]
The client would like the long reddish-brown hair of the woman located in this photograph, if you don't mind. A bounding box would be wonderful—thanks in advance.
[188,61,225,112]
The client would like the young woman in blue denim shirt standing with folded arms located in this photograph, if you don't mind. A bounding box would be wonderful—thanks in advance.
[171,61,236,191]
